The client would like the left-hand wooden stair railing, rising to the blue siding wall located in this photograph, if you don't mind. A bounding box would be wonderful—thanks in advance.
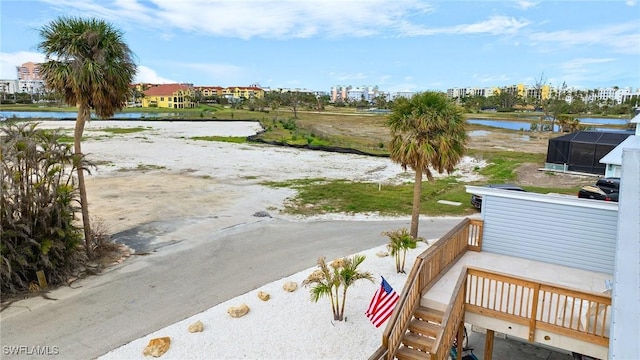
[369,218,482,359]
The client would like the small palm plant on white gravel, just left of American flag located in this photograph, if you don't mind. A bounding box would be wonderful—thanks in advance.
[302,255,373,321]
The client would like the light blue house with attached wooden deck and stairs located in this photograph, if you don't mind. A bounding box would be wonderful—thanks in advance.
[370,146,640,360]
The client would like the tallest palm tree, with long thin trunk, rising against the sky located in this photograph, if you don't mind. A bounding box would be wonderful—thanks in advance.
[38,17,136,257]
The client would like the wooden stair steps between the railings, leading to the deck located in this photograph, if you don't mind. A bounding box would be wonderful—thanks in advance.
[396,306,444,360]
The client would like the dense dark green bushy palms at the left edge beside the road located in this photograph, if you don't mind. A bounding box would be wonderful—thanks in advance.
[0,122,88,293]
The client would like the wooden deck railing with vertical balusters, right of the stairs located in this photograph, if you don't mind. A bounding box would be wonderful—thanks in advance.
[465,268,611,346]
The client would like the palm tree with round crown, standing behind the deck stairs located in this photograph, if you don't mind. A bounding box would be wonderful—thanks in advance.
[387,91,467,238]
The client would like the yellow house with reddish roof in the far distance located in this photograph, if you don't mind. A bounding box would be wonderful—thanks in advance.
[142,84,195,109]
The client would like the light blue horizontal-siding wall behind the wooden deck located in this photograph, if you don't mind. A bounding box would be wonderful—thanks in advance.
[482,194,618,274]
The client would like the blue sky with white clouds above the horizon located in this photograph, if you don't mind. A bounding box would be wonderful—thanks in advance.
[0,0,640,92]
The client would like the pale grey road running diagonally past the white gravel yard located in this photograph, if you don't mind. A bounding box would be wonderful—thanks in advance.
[0,218,461,359]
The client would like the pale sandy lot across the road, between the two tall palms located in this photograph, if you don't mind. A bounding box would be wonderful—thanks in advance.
[35,121,492,233]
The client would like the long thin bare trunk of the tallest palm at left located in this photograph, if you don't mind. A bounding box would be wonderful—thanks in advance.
[73,104,93,259]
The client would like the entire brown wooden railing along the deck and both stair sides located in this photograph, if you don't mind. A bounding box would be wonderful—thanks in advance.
[369,219,611,360]
